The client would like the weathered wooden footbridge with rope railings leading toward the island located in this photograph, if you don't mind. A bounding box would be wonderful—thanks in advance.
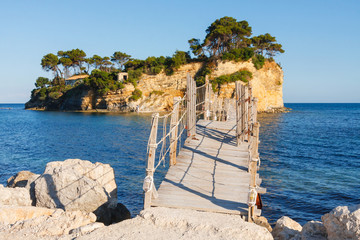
[143,75,265,221]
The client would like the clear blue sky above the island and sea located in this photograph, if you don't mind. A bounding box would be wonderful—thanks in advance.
[0,0,360,103]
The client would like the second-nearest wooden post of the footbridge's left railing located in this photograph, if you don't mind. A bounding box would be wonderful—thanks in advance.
[170,97,180,165]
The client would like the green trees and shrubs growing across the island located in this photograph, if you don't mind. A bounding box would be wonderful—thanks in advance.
[30,17,284,109]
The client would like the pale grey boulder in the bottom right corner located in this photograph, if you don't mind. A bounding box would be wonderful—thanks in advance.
[321,204,360,240]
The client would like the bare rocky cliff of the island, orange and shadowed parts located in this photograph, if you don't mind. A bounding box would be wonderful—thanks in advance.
[26,60,283,112]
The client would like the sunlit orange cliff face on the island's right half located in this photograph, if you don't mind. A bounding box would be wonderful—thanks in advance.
[131,60,284,112]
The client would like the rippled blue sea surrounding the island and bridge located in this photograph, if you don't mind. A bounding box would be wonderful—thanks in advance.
[0,104,360,224]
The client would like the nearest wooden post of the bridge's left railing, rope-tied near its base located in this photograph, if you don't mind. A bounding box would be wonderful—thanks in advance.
[144,113,159,209]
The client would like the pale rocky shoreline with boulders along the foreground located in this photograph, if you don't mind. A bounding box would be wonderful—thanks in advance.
[0,159,360,240]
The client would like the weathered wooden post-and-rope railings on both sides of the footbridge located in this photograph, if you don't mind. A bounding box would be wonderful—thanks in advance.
[143,75,260,221]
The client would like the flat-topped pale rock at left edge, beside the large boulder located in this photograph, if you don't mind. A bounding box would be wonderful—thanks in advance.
[0,184,32,206]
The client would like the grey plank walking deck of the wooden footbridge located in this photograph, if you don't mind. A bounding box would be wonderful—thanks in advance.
[151,120,260,215]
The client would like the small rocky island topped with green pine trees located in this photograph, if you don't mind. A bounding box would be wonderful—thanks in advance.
[25,17,284,112]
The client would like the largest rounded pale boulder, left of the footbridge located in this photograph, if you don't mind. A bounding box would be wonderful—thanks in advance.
[35,159,117,213]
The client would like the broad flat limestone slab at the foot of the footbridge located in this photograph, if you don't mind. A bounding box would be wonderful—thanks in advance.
[78,207,273,240]
